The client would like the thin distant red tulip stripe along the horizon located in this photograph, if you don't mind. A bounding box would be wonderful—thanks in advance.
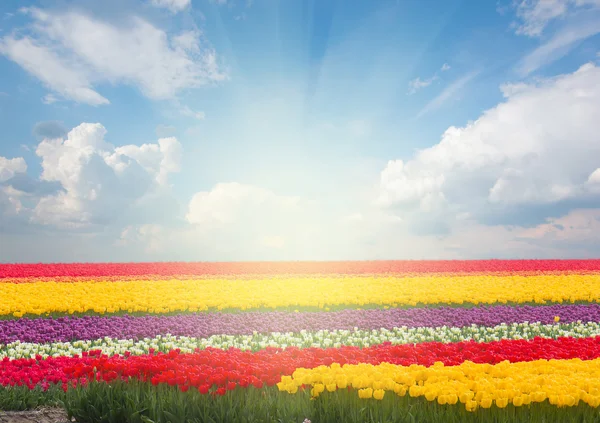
[0,259,600,278]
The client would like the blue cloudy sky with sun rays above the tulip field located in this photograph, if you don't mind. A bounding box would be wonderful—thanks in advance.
[0,0,600,262]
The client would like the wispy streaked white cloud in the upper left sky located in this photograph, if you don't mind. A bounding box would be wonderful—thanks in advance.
[0,8,226,105]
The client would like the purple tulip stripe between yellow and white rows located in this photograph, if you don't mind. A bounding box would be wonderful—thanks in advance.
[0,304,600,344]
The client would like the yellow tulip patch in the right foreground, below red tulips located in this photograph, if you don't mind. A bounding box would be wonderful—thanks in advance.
[277,359,600,411]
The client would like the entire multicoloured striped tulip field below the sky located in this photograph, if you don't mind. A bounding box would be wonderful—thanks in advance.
[0,260,600,423]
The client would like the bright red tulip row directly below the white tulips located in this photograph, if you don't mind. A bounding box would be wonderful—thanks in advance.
[0,337,600,392]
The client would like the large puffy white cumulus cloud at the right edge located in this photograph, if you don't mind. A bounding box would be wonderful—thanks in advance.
[377,64,600,229]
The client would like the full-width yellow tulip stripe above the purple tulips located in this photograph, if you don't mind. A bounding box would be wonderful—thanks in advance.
[0,274,600,317]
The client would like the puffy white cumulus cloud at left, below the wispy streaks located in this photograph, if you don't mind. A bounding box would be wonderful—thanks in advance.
[34,123,181,229]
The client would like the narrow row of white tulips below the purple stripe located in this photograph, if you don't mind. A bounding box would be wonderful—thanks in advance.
[0,322,600,359]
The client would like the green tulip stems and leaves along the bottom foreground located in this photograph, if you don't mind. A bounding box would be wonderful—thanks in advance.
[0,381,600,423]
